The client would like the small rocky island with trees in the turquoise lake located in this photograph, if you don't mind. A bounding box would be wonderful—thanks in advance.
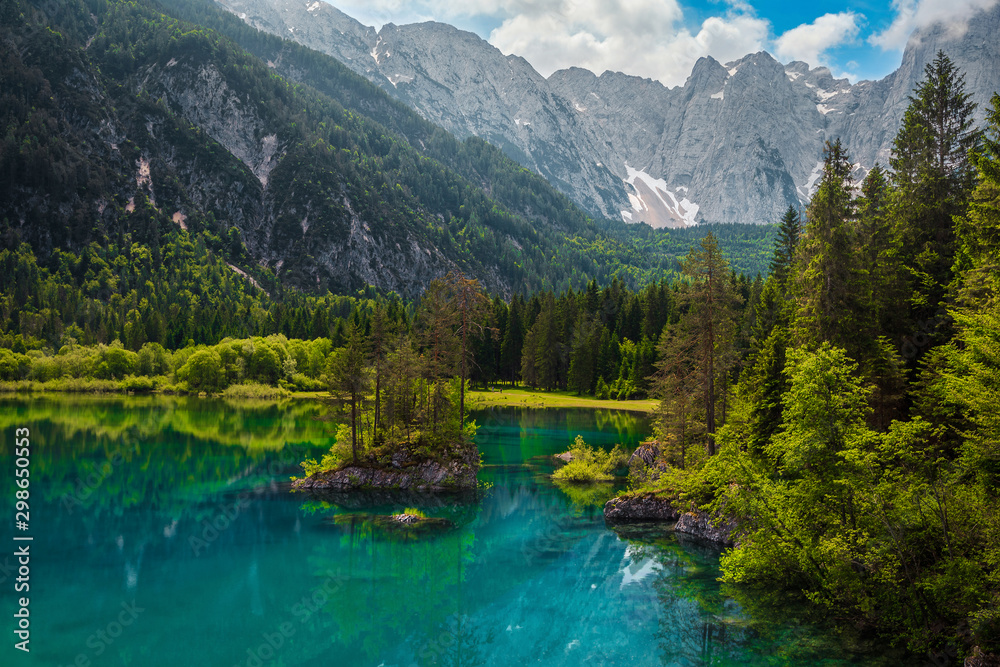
[292,284,488,491]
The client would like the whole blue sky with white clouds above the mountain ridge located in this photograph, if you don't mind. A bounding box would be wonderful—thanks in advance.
[328,0,1000,86]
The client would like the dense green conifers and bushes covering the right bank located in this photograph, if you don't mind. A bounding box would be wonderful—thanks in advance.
[599,55,1000,661]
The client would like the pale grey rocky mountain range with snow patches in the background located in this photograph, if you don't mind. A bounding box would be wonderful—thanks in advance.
[219,0,1000,227]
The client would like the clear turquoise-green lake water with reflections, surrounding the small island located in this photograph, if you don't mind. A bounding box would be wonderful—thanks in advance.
[0,397,903,667]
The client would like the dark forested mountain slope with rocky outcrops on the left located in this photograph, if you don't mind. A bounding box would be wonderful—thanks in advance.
[0,0,728,296]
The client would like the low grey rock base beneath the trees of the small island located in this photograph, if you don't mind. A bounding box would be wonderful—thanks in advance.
[292,448,479,491]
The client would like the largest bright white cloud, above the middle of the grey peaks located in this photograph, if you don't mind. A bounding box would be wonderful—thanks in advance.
[484,0,770,86]
